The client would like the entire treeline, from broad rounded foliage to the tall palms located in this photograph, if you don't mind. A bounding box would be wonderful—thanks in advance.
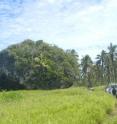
[0,40,117,90]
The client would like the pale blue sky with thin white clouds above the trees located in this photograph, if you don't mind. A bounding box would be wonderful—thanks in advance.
[0,0,117,58]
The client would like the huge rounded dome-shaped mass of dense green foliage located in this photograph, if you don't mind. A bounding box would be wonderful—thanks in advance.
[0,40,79,89]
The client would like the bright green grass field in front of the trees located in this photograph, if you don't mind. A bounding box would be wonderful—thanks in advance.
[0,88,117,124]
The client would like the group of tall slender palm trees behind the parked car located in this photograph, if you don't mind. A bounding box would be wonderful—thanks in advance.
[81,43,117,87]
